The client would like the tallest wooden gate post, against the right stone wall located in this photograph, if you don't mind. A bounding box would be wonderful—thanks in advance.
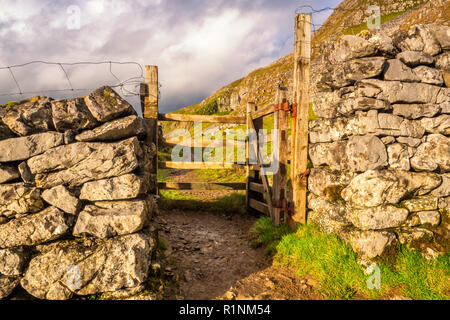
[291,14,311,224]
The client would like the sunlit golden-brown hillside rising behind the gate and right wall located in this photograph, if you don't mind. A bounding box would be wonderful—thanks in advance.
[163,0,450,133]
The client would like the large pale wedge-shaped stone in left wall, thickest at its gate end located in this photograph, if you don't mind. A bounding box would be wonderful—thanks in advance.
[30,138,142,188]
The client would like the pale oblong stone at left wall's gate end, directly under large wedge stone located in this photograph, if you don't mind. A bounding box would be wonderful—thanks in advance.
[80,174,149,201]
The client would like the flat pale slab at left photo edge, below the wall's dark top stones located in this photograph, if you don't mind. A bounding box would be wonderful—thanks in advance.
[0,132,64,162]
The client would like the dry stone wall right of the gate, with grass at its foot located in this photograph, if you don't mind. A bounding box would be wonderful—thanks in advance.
[308,25,450,261]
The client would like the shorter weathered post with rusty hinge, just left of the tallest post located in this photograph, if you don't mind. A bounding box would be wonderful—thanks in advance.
[272,87,289,226]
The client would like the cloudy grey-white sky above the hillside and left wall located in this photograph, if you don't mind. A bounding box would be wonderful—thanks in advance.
[0,0,340,112]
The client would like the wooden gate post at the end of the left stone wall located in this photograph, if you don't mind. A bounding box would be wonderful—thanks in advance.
[141,65,159,194]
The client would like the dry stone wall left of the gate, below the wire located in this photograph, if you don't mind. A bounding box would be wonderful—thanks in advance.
[0,87,157,300]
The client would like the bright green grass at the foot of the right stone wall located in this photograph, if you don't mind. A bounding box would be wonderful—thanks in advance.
[253,218,450,300]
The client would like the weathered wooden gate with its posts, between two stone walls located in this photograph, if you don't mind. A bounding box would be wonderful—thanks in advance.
[141,14,311,225]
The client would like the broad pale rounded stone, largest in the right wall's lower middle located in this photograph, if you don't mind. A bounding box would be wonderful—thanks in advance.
[341,170,408,208]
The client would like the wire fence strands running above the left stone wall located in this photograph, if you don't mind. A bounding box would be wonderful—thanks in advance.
[0,60,149,97]
